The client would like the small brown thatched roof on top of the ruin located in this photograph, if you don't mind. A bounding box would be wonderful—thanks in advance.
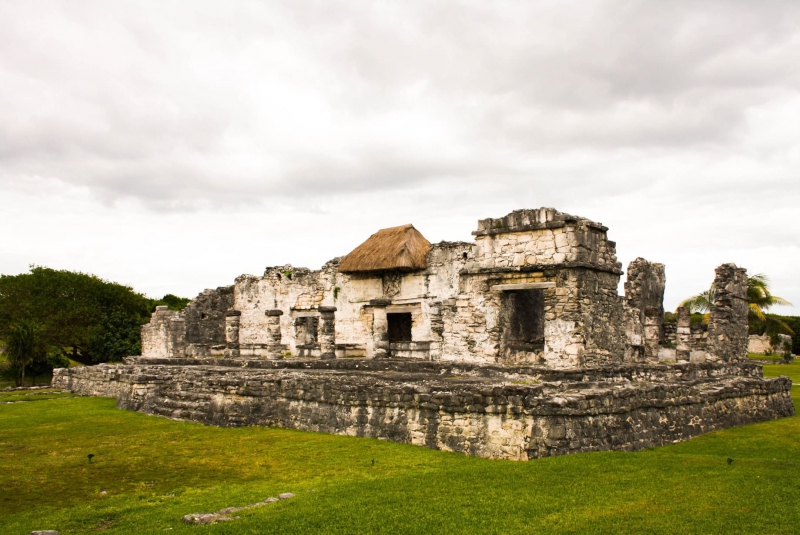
[339,225,431,273]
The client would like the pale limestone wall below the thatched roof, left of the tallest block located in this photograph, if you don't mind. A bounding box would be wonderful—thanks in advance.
[228,242,472,359]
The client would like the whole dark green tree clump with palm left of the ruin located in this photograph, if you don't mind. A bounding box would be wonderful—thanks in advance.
[0,266,189,384]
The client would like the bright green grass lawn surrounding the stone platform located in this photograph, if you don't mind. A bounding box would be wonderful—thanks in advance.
[0,364,800,534]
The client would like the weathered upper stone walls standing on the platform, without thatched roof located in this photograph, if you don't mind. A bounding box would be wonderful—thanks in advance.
[142,208,746,368]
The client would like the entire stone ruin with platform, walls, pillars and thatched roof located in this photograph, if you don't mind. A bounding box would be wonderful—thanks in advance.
[54,208,794,459]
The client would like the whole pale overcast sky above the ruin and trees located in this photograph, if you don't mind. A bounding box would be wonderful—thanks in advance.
[0,0,800,314]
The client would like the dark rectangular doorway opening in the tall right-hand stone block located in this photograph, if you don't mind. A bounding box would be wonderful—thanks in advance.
[503,289,544,358]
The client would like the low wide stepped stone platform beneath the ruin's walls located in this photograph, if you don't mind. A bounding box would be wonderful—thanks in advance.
[53,358,794,460]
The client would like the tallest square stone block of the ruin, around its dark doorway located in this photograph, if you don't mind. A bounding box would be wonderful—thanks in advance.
[454,208,625,368]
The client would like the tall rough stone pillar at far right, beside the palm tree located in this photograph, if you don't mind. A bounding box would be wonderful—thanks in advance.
[708,264,749,362]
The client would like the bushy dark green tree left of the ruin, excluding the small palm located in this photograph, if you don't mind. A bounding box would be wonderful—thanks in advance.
[0,266,188,365]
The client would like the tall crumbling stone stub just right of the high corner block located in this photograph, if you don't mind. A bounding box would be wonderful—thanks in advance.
[624,258,666,362]
